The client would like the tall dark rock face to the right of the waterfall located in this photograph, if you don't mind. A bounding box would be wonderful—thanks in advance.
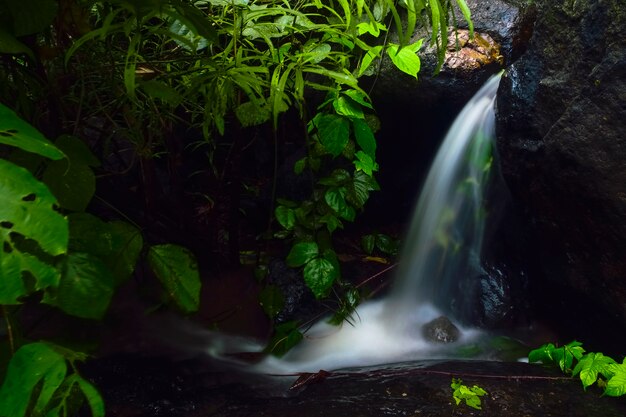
[497,0,626,340]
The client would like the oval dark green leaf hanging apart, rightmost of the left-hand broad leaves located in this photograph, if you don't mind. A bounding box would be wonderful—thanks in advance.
[148,244,201,313]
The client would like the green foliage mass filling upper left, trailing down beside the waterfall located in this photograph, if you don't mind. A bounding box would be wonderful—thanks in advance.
[0,0,471,368]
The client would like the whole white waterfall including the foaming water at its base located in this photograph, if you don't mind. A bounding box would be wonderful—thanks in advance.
[207,74,501,373]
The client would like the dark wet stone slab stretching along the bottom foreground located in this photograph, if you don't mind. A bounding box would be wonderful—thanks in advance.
[83,356,626,417]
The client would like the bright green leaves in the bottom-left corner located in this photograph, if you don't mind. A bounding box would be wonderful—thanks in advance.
[0,342,104,417]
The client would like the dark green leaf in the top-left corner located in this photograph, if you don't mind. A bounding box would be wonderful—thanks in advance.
[4,0,58,36]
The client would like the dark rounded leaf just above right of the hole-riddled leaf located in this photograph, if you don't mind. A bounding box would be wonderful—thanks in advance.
[42,160,96,211]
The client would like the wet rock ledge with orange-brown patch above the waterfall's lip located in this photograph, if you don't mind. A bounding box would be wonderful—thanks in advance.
[364,0,534,108]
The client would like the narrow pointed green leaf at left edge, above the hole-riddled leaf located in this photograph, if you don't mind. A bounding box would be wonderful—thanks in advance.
[0,104,65,159]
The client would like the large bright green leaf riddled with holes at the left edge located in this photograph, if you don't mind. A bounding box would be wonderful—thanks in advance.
[0,159,68,304]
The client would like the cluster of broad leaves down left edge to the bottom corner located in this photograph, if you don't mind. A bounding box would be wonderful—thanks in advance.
[0,104,200,417]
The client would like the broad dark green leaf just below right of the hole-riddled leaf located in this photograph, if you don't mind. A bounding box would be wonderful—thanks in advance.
[42,253,115,319]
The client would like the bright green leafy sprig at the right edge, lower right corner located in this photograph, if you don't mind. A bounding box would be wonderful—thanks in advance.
[528,341,626,397]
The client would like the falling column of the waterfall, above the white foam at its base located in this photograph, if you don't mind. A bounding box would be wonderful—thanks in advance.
[386,73,501,319]
